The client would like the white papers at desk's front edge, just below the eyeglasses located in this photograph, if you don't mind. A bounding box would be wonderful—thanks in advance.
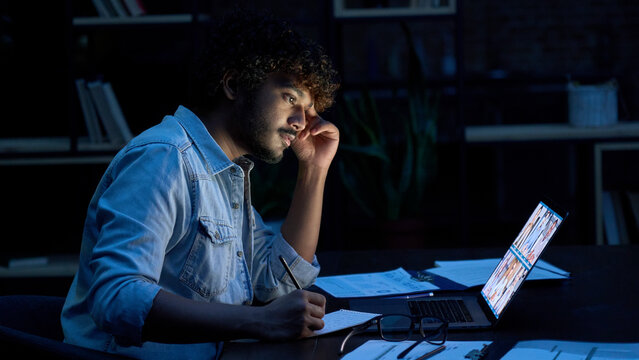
[342,340,491,360]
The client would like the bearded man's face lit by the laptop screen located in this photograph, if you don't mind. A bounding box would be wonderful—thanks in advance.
[231,74,317,164]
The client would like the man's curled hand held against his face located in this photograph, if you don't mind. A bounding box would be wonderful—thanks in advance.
[291,115,339,169]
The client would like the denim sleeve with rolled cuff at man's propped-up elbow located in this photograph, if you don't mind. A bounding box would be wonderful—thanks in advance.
[253,209,320,302]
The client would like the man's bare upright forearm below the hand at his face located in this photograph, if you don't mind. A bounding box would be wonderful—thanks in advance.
[282,163,328,262]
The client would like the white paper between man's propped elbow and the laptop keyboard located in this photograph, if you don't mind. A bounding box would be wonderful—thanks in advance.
[315,267,439,298]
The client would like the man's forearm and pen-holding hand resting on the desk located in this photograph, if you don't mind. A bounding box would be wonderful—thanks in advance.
[142,290,326,344]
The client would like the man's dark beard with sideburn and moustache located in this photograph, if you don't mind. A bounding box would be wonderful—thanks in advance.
[230,93,296,164]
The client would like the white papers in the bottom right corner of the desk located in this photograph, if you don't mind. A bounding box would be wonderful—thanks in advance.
[502,340,639,360]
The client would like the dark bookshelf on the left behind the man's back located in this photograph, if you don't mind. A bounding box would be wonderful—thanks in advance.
[0,0,210,268]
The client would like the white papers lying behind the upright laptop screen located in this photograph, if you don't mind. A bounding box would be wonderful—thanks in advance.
[427,259,570,287]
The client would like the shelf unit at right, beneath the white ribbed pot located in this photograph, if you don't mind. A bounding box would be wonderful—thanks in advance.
[465,121,639,245]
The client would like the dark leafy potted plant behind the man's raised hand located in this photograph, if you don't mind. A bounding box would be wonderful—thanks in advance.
[338,22,439,246]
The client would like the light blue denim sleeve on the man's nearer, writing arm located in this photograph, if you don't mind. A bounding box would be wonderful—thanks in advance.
[87,144,190,346]
